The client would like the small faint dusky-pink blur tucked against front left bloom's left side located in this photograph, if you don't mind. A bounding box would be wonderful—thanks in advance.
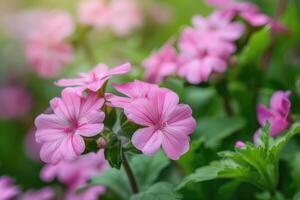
[24,128,42,162]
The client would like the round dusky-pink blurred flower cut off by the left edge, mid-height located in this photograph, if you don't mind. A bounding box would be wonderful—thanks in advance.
[0,85,32,119]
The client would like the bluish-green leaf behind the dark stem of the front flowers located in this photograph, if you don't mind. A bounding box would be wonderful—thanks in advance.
[90,151,170,200]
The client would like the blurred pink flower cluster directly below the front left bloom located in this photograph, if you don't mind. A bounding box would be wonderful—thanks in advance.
[41,150,108,200]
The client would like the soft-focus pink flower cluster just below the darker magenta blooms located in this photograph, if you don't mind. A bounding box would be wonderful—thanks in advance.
[144,11,244,84]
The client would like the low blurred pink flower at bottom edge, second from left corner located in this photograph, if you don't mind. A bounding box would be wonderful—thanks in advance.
[19,187,54,200]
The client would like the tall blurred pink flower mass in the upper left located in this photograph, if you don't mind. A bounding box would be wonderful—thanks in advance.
[25,11,74,78]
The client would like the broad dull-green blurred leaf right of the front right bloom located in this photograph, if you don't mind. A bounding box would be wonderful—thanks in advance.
[196,117,245,148]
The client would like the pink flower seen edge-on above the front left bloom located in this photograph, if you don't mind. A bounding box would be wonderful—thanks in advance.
[56,63,131,93]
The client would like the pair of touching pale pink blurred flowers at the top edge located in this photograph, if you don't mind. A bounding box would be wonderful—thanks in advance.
[78,0,142,36]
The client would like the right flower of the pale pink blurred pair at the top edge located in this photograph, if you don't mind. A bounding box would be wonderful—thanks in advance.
[110,0,143,36]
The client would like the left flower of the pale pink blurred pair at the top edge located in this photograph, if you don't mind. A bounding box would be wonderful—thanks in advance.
[78,0,114,28]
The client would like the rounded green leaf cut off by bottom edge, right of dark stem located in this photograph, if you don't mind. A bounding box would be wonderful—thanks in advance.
[130,182,182,200]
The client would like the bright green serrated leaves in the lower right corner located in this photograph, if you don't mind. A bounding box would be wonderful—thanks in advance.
[178,124,300,192]
